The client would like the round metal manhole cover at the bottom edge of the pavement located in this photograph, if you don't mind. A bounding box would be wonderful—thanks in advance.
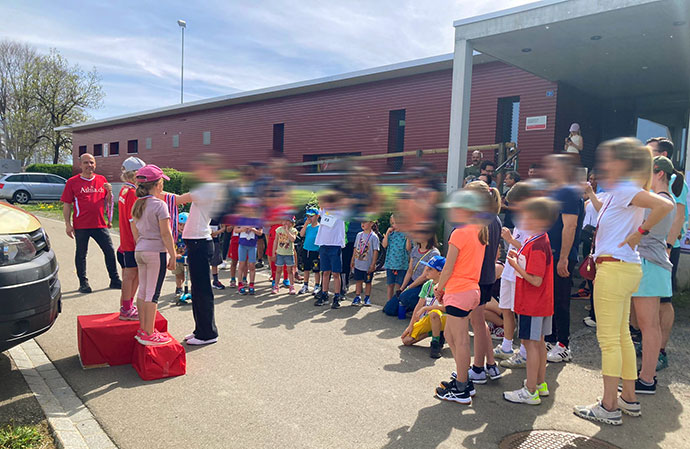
[498,430,620,449]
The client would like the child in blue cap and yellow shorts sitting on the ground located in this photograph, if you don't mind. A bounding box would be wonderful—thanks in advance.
[400,256,446,359]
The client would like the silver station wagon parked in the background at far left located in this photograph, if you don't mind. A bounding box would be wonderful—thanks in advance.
[0,173,67,204]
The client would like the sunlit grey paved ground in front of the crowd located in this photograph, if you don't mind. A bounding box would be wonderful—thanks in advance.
[13,215,690,449]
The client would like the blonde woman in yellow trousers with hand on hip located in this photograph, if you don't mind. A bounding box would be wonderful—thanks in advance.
[573,137,673,425]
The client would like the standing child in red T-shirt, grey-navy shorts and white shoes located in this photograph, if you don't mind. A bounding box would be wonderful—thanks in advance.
[503,198,559,405]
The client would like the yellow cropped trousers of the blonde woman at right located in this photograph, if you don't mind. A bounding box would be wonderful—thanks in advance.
[594,262,642,380]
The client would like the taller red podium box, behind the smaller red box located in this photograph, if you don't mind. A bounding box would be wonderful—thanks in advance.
[77,312,168,368]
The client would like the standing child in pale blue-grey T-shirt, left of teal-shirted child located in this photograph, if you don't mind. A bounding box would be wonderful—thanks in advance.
[350,221,379,307]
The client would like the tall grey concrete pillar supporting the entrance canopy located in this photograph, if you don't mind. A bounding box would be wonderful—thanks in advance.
[446,39,473,193]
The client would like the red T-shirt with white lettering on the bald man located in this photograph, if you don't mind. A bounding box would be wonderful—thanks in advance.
[60,175,108,229]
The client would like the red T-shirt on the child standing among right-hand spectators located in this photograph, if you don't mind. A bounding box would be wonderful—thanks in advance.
[515,234,553,316]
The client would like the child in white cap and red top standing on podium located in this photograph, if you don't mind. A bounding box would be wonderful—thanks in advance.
[117,156,146,321]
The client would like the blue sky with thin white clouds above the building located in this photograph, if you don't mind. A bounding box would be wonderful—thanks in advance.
[0,0,530,118]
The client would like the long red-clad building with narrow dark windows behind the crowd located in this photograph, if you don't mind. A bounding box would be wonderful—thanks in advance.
[63,55,569,182]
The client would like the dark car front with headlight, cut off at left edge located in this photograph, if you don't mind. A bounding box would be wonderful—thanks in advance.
[0,202,62,351]
